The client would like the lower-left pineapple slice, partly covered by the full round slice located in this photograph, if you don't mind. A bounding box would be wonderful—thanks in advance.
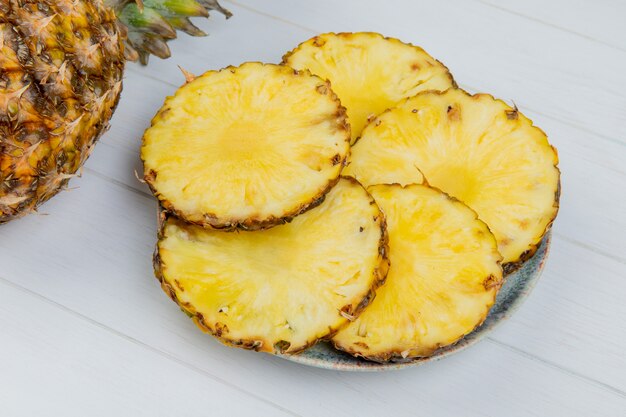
[154,179,388,353]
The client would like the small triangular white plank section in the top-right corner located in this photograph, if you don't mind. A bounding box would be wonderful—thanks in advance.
[476,0,626,51]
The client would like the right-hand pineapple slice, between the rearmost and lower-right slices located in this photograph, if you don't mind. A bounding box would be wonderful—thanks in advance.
[344,89,560,273]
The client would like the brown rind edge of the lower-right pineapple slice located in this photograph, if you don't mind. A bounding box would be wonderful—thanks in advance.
[331,183,504,363]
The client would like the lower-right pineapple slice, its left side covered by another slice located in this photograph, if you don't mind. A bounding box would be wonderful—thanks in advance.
[333,184,502,362]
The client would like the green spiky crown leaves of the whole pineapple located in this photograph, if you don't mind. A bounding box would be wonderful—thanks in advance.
[105,0,232,64]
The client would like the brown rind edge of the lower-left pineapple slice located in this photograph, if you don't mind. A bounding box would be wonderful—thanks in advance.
[153,176,390,354]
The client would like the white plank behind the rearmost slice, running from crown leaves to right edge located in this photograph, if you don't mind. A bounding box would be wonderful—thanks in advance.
[211,0,626,142]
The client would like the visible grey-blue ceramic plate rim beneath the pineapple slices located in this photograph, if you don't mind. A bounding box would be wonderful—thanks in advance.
[282,233,551,371]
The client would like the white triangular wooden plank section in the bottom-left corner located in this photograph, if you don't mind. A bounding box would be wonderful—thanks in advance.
[0,277,294,417]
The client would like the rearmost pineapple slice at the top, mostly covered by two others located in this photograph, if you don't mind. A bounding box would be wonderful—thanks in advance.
[283,32,455,143]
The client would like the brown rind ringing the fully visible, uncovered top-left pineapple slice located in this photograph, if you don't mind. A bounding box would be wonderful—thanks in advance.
[141,62,350,231]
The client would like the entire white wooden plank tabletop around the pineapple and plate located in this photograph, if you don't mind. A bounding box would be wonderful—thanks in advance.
[0,0,626,417]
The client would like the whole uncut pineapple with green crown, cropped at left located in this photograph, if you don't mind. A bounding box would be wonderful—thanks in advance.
[0,0,229,223]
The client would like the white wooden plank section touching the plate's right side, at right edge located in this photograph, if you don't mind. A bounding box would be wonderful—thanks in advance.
[492,238,626,392]
